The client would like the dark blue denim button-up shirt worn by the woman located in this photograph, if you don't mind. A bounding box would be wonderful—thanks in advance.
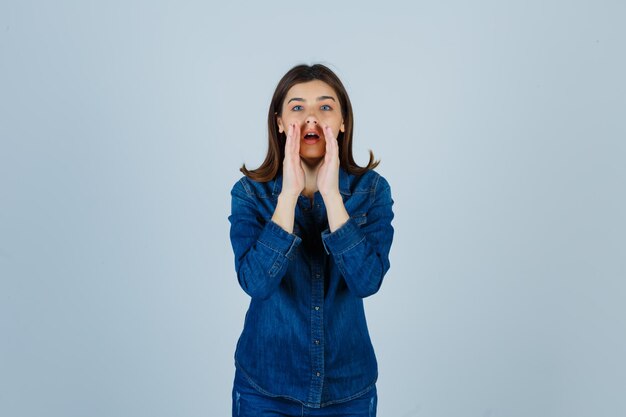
[229,170,393,408]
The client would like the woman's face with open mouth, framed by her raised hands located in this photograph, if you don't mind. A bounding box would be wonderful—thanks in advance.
[276,80,344,164]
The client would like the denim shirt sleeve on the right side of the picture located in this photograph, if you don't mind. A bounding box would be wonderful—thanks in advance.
[322,177,393,297]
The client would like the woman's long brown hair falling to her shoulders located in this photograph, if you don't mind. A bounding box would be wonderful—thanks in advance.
[240,64,380,182]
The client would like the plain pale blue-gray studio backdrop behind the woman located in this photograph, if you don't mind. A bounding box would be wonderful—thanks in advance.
[0,0,626,417]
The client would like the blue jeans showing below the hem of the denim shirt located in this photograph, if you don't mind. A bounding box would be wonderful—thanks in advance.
[233,372,378,417]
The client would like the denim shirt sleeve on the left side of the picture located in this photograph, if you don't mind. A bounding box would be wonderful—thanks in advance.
[228,181,302,299]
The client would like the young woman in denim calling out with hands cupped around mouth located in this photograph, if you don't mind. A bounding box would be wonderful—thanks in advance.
[229,65,393,417]
